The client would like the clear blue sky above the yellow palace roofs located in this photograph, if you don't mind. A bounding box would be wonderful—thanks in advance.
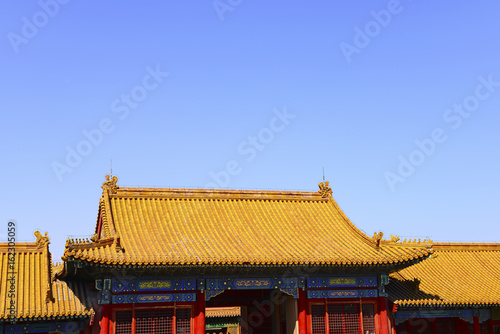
[0,0,500,260]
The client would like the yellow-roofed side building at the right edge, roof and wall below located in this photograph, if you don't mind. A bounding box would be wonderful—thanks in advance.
[387,243,500,334]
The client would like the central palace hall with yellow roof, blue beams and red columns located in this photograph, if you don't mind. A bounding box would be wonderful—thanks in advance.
[57,177,432,334]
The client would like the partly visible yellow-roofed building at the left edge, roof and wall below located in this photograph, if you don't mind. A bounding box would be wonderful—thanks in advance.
[0,231,96,334]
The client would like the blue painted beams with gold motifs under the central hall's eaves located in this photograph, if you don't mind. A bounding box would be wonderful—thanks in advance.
[96,276,381,304]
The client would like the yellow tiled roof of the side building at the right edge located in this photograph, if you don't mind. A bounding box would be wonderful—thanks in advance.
[387,243,500,306]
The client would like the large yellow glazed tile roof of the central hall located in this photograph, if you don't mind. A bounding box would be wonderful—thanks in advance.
[63,177,432,265]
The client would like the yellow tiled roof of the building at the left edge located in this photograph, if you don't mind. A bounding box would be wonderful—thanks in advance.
[0,232,94,320]
